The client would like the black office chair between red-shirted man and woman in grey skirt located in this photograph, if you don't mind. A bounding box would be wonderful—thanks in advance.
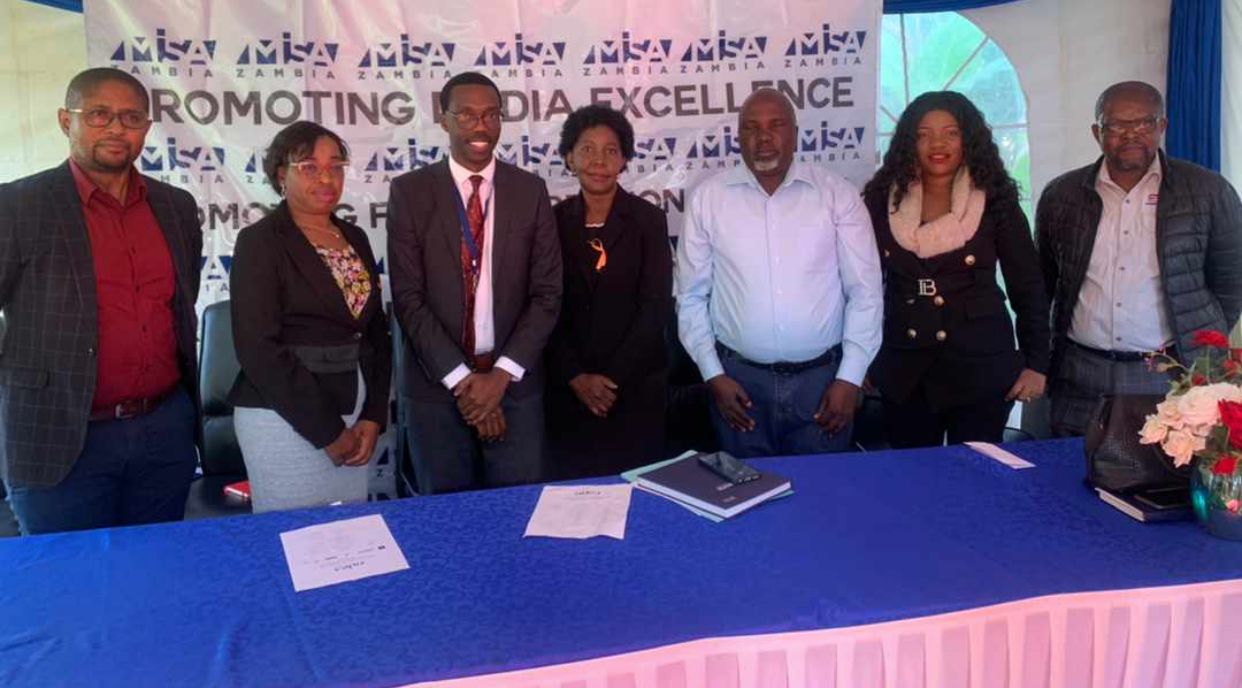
[185,301,250,519]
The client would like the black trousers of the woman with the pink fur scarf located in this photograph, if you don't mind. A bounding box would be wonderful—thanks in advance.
[884,385,1013,450]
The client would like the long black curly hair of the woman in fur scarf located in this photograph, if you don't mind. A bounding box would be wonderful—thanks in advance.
[863,91,1018,204]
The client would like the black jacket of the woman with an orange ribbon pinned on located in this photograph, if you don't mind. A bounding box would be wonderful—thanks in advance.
[548,189,673,389]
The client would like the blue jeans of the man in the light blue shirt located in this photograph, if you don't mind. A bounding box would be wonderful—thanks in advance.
[712,349,852,458]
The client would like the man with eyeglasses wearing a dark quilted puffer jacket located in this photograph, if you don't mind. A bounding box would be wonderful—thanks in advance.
[1035,81,1242,436]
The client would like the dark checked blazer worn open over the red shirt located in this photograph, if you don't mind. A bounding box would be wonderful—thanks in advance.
[0,163,202,486]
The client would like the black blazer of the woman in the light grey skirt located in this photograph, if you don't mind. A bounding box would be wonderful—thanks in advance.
[229,202,392,448]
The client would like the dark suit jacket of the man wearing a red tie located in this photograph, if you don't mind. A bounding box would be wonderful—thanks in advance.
[388,160,561,402]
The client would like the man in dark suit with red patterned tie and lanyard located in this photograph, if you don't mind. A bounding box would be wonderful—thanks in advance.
[388,72,561,494]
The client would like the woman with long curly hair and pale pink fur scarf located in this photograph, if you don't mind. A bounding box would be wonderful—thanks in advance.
[863,91,1048,447]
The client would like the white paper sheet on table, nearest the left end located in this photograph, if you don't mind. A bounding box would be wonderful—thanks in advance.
[281,514,410,592]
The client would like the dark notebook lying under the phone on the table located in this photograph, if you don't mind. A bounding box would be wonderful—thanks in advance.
[636,455,790,518]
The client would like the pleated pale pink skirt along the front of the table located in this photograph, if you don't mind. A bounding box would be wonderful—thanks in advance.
[416,579,1242,688]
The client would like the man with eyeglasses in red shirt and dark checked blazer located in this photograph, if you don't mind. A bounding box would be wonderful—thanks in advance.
[0,68,202,534]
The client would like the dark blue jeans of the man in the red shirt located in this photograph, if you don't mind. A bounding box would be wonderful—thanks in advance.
[9,387,199,535]
